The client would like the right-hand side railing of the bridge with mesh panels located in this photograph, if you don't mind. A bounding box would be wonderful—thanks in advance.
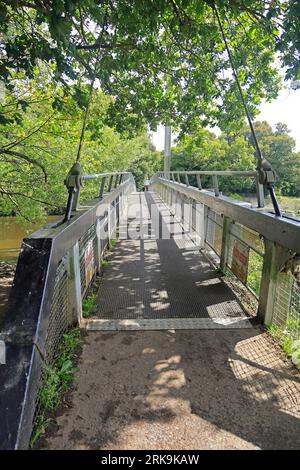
[150,172,300,338]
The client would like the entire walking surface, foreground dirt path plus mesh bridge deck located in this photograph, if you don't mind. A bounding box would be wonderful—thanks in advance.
[40,193,300,450]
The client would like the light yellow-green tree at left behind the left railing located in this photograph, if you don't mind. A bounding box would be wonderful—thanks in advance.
[0,77,158,220]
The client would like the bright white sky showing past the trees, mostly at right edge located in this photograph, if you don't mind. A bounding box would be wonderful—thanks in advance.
[152,89,300,151]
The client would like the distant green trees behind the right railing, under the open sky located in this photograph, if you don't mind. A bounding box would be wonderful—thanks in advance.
[172,121,300,196]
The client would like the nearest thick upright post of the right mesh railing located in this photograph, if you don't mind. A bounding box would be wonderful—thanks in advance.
[257,240,290,325]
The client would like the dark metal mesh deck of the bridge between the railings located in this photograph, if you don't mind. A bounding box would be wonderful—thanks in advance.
[90,193,250,329]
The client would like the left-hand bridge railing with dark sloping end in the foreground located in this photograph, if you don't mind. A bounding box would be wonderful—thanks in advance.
[0,173,135,449]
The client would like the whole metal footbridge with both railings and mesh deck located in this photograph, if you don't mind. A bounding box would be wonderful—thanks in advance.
[0,172,300,449]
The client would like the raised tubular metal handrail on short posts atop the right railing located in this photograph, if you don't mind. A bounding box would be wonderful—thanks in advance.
[155,170,265,208]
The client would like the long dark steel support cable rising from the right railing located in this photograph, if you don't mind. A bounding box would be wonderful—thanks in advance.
[212,1,281,217]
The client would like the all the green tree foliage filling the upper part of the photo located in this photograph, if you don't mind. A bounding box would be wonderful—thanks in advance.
[0,0,300,217]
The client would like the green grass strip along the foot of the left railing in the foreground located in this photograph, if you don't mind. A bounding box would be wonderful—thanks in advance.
[30,328,81,448]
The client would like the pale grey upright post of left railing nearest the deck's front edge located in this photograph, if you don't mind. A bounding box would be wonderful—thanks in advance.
[68,242,82,324]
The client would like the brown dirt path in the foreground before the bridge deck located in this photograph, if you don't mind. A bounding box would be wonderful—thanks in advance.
[41,329,300,449]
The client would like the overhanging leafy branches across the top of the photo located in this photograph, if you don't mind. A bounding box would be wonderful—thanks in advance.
[0,0,299,132]
